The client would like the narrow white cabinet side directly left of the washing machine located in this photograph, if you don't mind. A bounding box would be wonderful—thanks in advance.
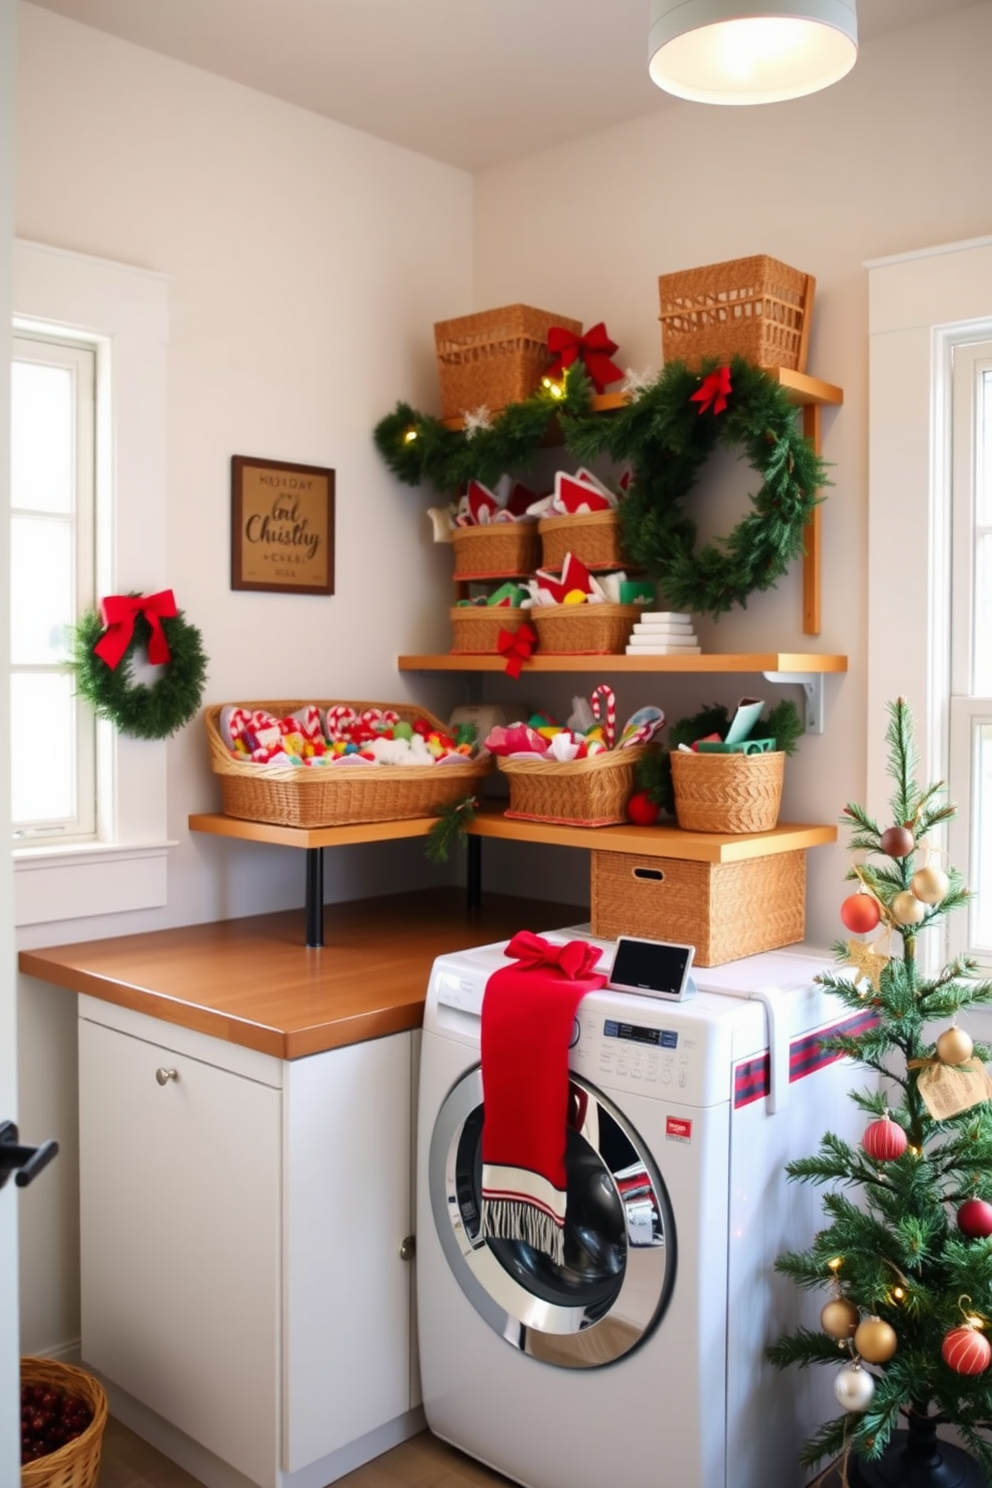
[283,1033,412,1472]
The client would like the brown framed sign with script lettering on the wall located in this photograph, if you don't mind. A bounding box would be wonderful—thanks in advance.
[231,455,335,594]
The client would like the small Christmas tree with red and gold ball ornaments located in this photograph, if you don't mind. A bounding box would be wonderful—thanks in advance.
[769,698,992,1488]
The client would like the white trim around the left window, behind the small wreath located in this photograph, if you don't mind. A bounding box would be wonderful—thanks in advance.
[12,240,174,926]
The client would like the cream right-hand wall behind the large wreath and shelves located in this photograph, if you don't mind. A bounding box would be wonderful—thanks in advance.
[473,3,992,945]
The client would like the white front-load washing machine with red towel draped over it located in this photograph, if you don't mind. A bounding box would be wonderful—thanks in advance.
[416,927,872,1488]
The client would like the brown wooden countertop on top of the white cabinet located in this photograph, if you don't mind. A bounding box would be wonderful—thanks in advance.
[18,888,589,1059]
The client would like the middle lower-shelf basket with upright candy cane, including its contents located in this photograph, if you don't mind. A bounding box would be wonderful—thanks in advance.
[485,683,665,827]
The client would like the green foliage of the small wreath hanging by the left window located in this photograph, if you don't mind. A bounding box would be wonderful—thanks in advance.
[70,610,207,740]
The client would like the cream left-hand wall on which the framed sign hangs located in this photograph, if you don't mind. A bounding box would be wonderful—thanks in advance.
[14,4,471,1350]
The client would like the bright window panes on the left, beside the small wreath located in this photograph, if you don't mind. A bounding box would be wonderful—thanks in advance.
[9,338,97,842]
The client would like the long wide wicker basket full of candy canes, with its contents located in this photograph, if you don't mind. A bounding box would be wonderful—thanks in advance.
[204,699,492,827]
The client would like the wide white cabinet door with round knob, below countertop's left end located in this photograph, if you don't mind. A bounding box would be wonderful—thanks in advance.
[79,1021,281,1484]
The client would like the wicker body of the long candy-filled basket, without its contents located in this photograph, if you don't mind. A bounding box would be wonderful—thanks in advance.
[204,698,491,827]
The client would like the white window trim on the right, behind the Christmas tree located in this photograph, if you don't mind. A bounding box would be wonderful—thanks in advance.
[866,237,992,970]
